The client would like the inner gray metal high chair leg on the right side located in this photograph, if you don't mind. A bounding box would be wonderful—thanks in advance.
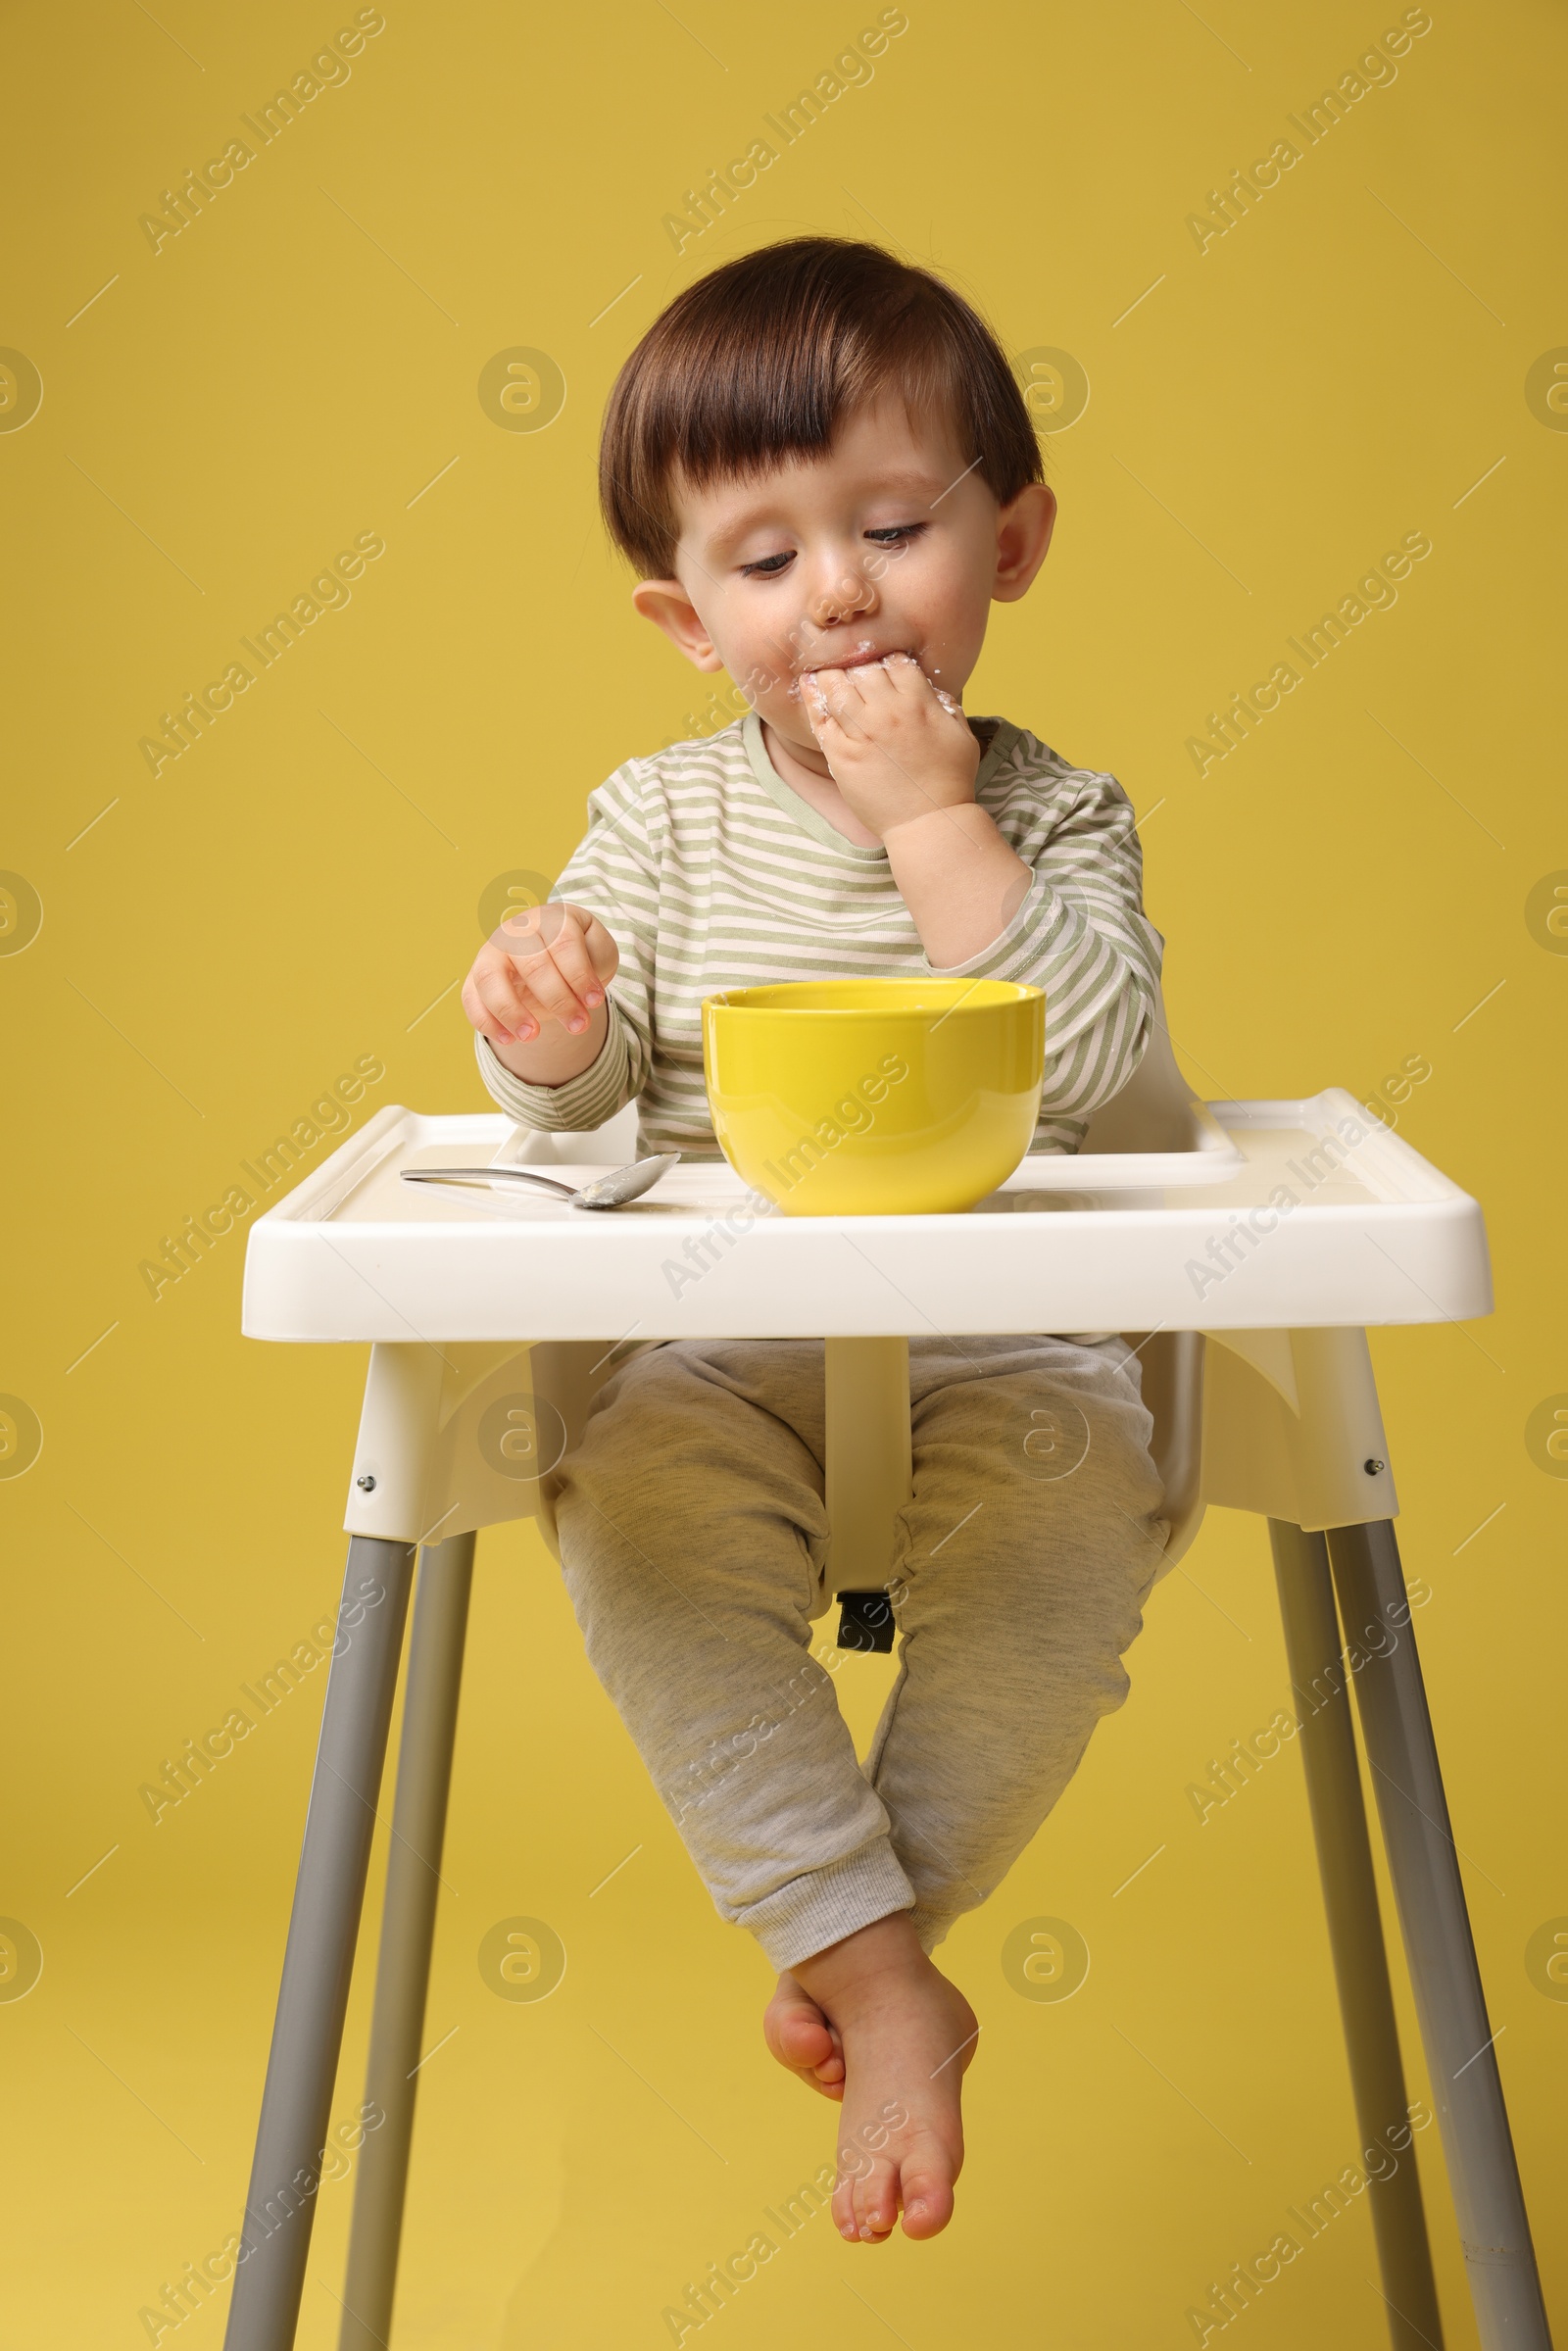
[1269,1519,1444,2351]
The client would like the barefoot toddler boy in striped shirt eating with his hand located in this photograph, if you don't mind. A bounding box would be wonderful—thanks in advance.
[464,237,1166,2243]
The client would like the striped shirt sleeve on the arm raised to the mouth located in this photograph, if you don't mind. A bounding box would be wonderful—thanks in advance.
[929,753,1159,1150]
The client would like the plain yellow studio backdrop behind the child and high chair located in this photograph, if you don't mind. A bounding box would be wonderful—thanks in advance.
[0,0,1568,2351]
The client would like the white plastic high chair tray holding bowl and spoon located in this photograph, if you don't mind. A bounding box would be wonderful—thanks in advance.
[242,1086,1493,1345]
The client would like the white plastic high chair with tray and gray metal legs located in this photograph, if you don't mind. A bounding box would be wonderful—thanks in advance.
[225,1006,1549,2351]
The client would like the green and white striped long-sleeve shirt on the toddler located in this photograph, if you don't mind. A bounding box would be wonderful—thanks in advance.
[475,714,1161,1161]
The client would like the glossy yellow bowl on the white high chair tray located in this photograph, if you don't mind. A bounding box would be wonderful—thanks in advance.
[703,978,1046,1215]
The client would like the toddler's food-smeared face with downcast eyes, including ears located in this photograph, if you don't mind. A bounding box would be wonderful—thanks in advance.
[632,395,1055,764]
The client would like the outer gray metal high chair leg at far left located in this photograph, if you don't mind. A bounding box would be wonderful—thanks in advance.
[223,1536,414,2351]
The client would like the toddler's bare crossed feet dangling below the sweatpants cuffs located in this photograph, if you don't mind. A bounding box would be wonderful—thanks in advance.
[780,1911,980,2245]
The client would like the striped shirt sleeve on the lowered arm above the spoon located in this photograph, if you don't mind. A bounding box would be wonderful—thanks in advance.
[475,759,659,1133]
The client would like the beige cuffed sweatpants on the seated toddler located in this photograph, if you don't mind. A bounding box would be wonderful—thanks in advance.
[555,1338,1166,1968]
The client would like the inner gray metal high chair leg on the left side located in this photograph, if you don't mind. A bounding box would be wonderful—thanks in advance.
[338,1536,475,2351]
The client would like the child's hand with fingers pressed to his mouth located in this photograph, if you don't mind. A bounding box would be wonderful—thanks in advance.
[802,654,980,837]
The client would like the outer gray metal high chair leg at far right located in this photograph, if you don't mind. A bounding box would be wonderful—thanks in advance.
[1328,1519,1551,2351]
